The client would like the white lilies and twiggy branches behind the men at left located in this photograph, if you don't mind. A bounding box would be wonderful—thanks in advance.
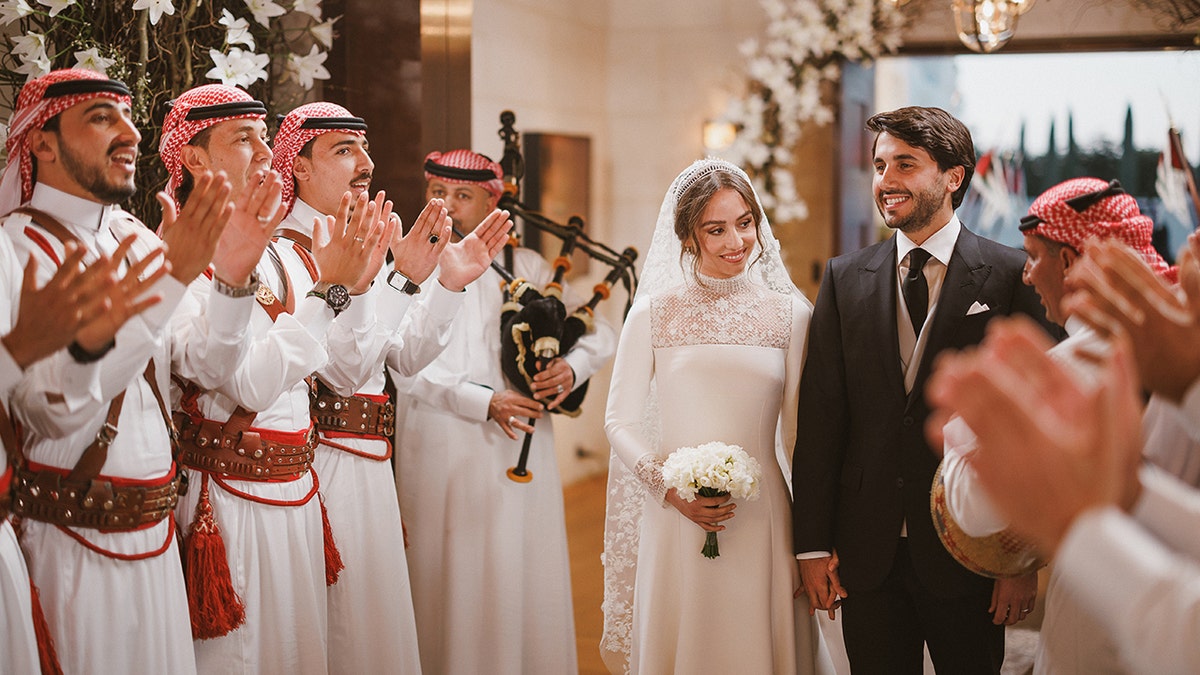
[0,0,341,220]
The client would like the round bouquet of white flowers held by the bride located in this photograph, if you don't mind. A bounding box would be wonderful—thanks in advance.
[662,441,762,557]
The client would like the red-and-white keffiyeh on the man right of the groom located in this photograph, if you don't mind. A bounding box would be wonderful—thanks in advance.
[1021,178,1177,282]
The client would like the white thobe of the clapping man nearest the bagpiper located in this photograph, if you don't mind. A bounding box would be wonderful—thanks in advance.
[280,199,466,674]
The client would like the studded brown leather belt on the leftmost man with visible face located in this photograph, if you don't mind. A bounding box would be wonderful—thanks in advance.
[12,468,179,530]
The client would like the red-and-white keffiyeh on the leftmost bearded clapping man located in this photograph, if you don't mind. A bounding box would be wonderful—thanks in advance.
[0,68,131,214]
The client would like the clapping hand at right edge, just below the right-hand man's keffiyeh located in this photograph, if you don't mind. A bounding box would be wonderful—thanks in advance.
[1063,234,1200,402]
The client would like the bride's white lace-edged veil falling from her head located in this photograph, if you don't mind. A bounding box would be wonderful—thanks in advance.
[600,157,812,673]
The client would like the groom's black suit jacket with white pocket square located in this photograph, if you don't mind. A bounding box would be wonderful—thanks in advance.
[792,227,1049,597]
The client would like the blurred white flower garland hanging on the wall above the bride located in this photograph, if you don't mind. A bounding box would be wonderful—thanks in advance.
[718,0,904,222]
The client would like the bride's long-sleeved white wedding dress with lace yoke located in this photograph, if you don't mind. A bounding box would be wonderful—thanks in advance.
[605,274,832,675]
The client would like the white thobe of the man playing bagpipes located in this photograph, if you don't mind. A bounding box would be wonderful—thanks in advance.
[396,249,616,675]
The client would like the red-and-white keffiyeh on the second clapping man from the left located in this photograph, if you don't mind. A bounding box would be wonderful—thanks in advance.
[158,84,266,198]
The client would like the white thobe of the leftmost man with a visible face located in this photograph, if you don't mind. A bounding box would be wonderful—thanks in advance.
[4,185,207,673]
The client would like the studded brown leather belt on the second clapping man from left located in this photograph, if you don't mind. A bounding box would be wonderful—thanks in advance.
[174,412,317,480]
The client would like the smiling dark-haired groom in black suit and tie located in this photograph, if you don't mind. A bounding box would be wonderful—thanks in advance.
[792,107,1044,675]
